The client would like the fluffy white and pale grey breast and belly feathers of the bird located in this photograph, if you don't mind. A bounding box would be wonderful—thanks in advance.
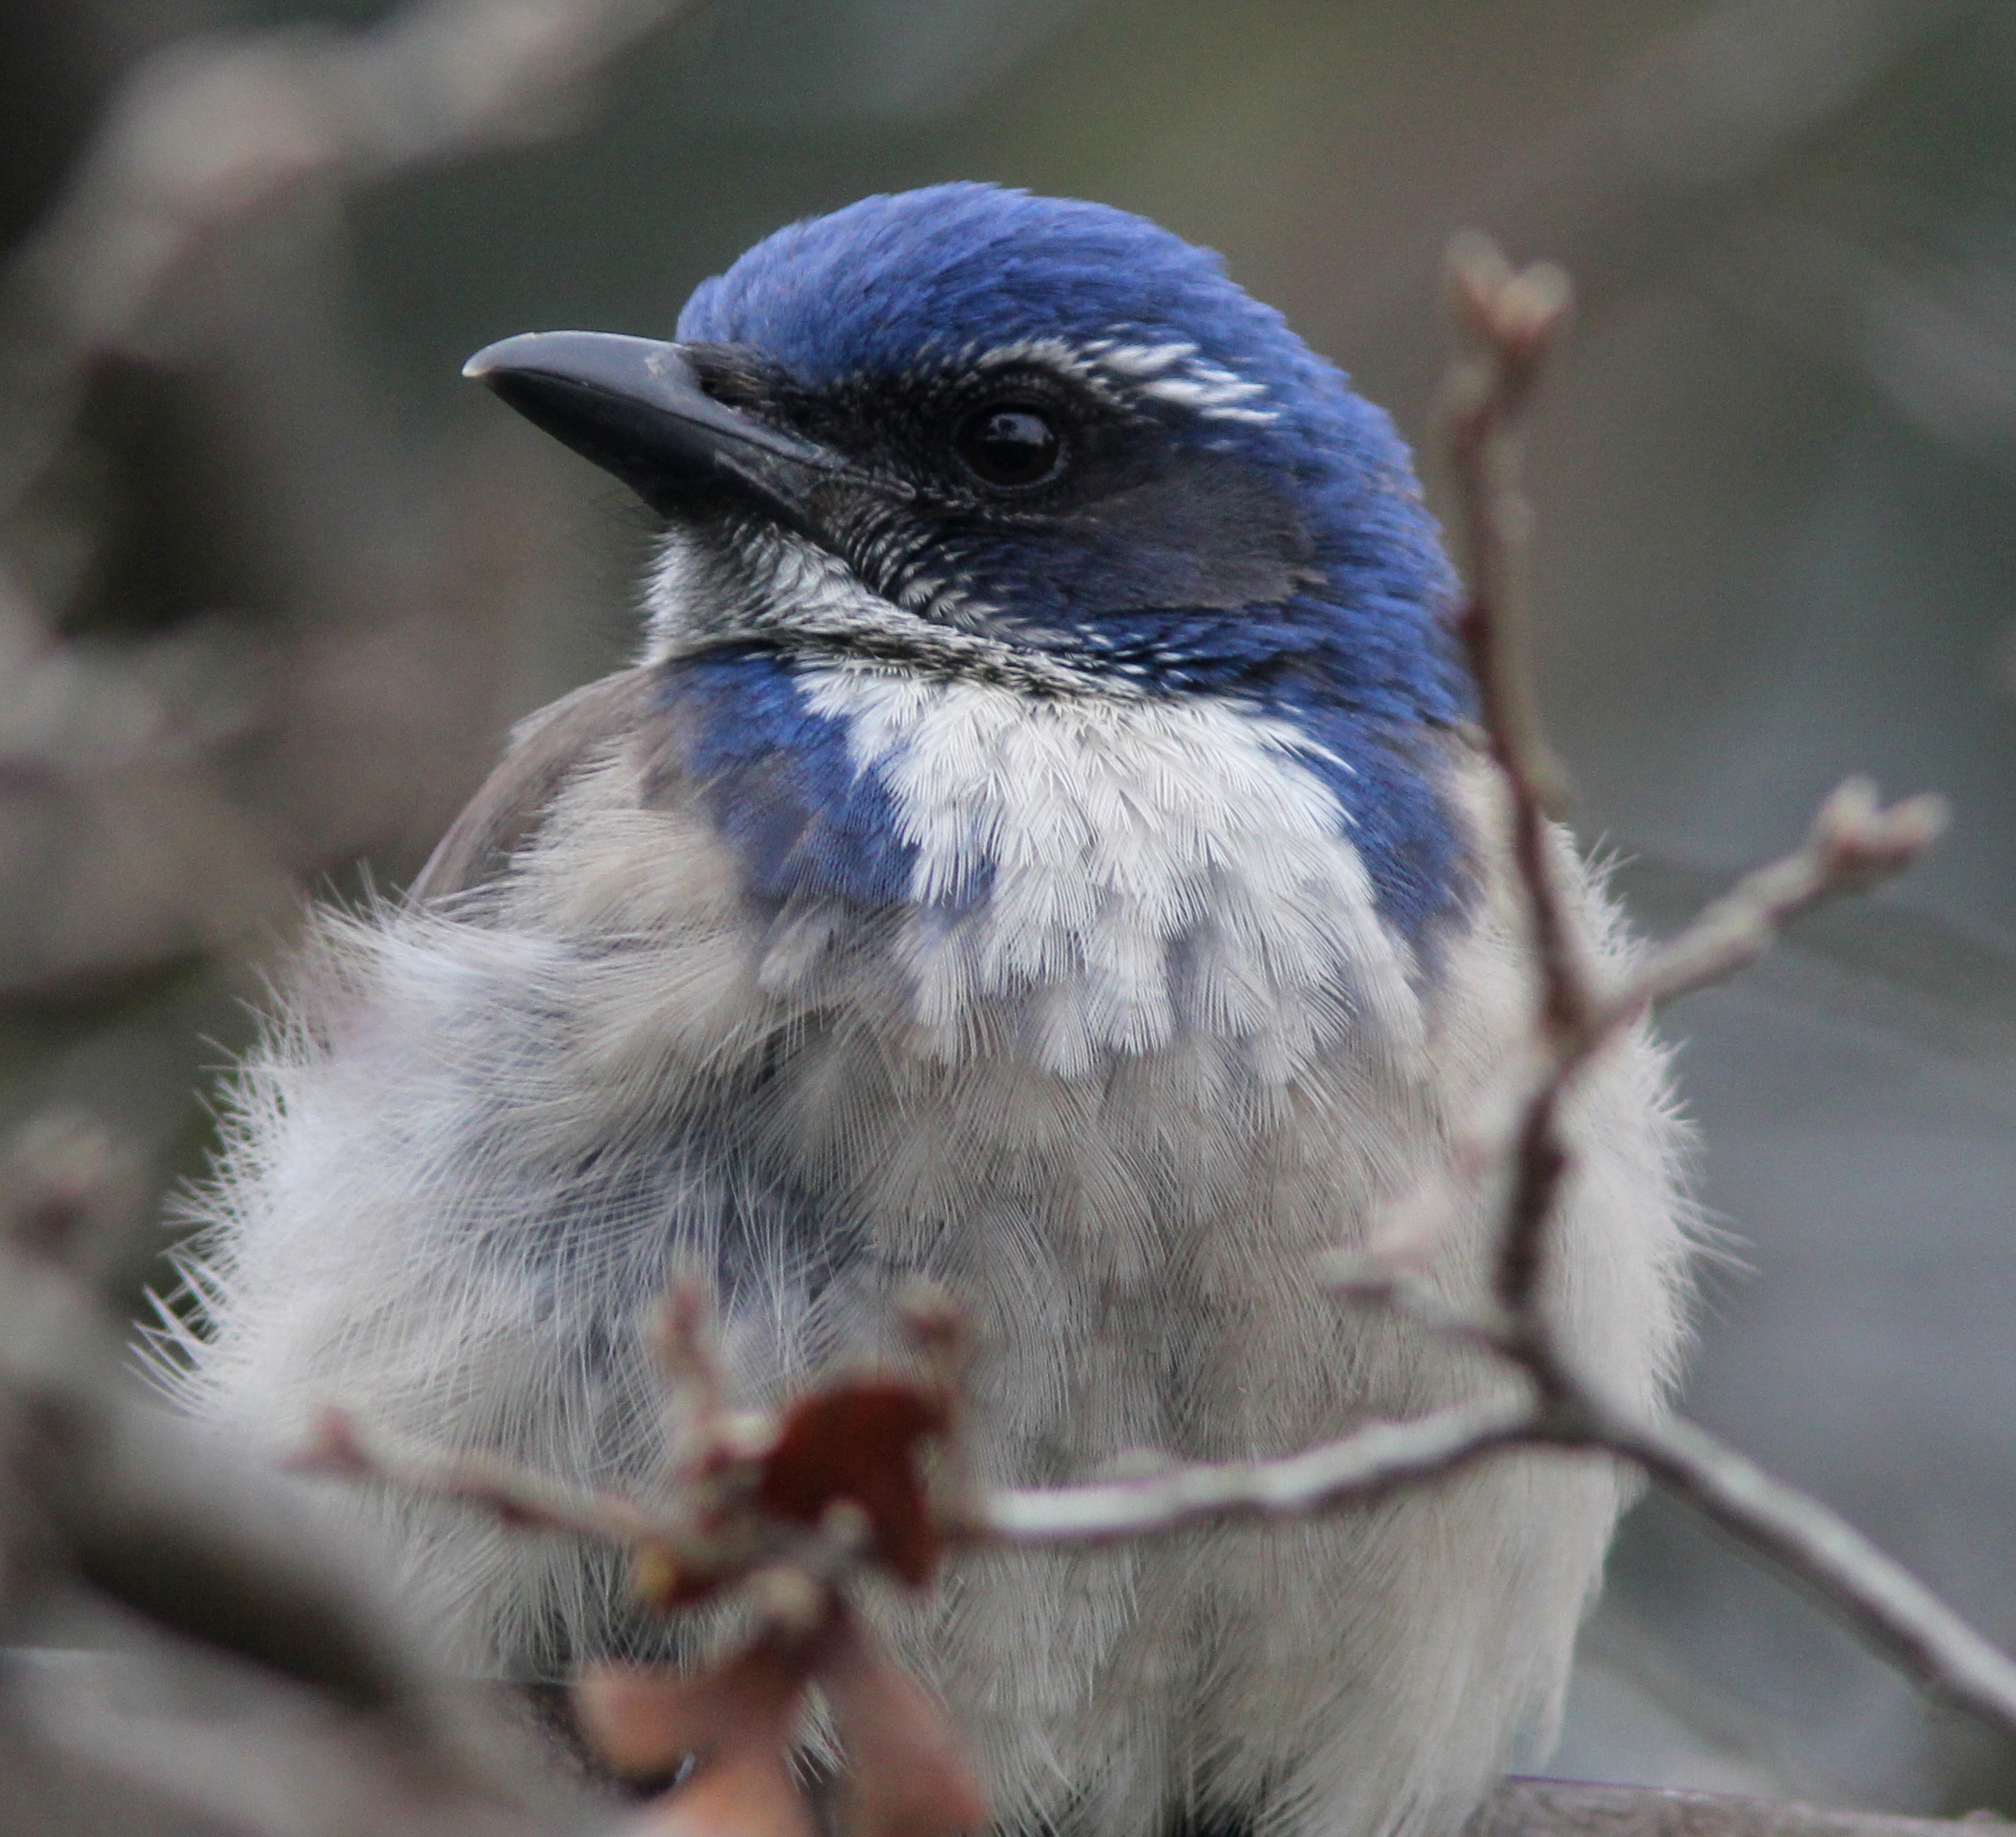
[165,665,1682,1837]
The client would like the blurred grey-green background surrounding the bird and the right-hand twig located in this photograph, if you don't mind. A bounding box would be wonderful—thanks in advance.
[0,0,2016,1813]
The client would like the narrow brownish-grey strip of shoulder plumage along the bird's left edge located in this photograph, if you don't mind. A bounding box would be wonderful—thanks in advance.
[409,665,653,904]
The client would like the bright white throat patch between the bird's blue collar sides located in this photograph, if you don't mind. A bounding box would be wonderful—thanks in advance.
[802,661,1421,1079]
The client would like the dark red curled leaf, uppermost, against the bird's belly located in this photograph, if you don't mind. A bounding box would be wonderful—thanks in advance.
[758,1377,946,1587]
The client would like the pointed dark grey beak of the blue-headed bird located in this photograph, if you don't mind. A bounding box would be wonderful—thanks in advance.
[461,331,853,529]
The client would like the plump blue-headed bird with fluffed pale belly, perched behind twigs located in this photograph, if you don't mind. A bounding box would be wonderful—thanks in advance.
[165,183,1687,1837]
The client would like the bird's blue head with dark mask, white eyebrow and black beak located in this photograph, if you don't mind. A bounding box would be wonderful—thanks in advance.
[468,183,1468,929]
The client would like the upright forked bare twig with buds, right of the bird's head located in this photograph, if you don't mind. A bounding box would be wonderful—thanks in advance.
[1419,238,2016,1734]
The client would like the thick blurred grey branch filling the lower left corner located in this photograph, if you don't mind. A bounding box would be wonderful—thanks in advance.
[0,1121,588,1837]
